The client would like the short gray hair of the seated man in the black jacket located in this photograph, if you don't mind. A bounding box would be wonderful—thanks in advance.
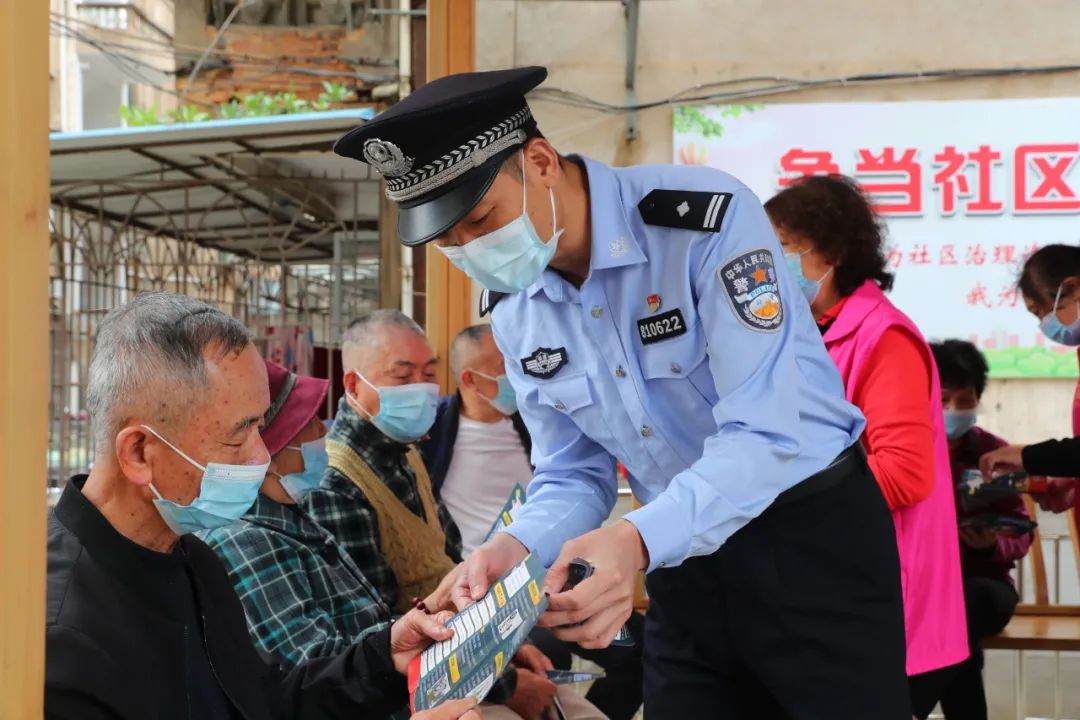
[86,293,252,452]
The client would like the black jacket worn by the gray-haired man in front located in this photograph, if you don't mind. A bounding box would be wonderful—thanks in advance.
[45,476,407,720]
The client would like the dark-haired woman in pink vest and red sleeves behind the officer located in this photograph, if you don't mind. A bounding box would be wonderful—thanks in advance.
[765,176,968,720]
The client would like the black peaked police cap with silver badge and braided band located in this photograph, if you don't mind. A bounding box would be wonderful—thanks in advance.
[334,67,548,245]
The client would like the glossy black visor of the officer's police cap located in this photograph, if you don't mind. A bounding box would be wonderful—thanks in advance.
[397,146,521,247]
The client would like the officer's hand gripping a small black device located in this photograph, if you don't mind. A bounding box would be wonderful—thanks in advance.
[540,520,649,648]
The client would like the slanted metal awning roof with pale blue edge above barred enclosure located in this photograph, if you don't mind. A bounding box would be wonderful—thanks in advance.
[50,108,388,262]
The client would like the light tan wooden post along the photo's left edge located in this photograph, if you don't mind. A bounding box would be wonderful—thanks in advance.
[0,2,50,720]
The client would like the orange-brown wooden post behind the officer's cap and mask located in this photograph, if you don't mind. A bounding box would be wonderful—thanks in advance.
[426,0,476,393]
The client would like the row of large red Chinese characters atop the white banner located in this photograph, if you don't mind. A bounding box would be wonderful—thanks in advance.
[777,142,1080,217]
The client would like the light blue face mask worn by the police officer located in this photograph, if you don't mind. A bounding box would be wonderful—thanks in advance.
[435,152,563,293]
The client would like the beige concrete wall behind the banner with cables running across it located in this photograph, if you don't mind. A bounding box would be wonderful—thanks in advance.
[476,0,1080,441]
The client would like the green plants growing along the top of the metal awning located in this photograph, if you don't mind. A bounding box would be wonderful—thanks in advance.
[120,82,356,127]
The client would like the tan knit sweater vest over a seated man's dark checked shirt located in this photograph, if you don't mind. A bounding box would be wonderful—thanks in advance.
[326,440,455,613]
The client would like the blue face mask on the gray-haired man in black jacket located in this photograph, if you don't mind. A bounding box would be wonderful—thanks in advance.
[143,425,270,535]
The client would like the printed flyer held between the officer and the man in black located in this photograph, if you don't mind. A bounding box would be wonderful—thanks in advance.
[408,555,548,712]
